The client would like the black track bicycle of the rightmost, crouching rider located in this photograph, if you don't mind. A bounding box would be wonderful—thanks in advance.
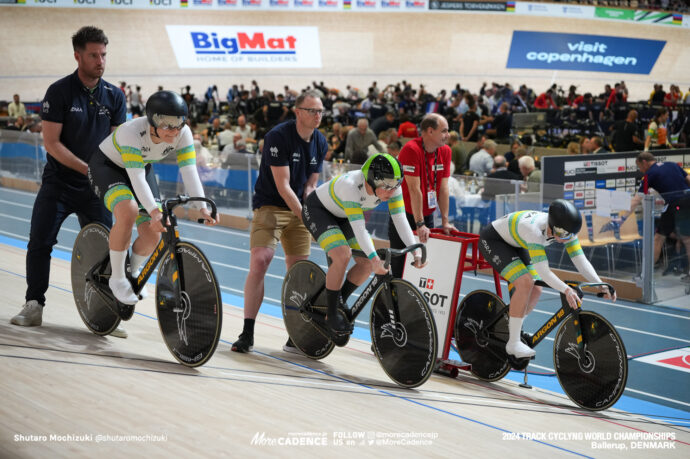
[455,281,628,411]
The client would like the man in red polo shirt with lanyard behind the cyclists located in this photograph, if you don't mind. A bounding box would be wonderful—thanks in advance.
[388,113,455,278]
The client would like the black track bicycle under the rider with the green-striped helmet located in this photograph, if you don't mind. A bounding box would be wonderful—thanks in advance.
[281,244,438,388]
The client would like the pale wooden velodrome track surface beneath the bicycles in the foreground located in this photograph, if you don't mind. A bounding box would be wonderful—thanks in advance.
[0,186,690,458]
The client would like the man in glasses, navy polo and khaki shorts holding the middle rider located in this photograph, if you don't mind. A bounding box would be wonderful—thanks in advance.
[232,91,328,352]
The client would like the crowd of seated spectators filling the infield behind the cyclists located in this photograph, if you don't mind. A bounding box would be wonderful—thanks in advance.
[0,80,690,188]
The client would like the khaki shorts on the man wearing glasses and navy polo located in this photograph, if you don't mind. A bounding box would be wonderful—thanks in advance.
[249,206,311,256]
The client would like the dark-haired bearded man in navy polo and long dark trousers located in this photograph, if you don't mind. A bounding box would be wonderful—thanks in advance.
[11,26,127,337]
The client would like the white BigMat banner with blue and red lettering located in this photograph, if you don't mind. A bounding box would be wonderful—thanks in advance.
[165,25,321,68]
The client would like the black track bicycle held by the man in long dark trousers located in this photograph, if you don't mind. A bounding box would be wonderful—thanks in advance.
[71,196,223,367]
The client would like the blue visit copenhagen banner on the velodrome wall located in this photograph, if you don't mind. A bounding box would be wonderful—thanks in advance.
[506,30,666,75]
